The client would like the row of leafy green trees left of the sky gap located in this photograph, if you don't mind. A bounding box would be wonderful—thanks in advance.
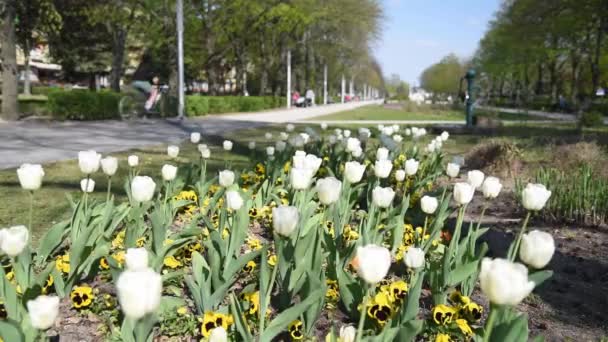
[0,0,384,117]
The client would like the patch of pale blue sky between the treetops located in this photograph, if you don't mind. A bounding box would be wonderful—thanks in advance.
[374,0,501,84]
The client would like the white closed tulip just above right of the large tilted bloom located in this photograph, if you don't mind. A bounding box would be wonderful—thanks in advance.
[519,230,555,269]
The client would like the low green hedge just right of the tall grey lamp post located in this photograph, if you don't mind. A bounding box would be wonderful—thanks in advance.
[186,95,283,116]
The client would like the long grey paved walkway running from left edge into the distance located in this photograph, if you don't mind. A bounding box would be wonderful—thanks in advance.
[0,101,378,169]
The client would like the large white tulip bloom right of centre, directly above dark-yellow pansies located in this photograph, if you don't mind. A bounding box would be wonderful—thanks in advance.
[353,244,391,285]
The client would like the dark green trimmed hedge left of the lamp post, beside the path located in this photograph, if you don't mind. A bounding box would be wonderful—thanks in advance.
[47,90,121,120]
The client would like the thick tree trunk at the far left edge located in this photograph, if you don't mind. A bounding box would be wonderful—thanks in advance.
[0,0,19,120]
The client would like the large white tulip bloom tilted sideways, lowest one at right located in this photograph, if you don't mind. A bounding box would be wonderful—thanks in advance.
[479,258,534,305]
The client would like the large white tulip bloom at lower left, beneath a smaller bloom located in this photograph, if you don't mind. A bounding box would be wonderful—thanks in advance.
[116,268,163,320]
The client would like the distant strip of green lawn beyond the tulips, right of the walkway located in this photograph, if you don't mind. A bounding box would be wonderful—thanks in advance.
[310,105,464,121]
